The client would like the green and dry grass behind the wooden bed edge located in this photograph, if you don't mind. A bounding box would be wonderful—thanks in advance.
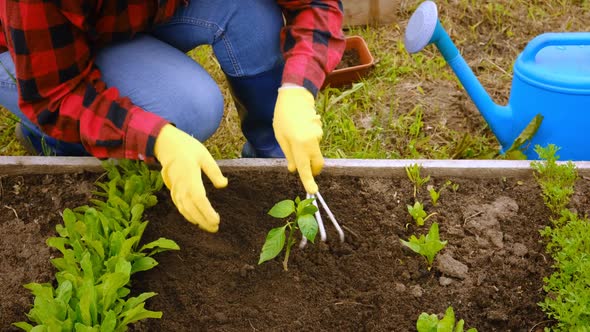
[0,0,590,159]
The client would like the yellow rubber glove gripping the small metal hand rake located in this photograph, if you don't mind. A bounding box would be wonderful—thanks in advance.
[273,87,324,194]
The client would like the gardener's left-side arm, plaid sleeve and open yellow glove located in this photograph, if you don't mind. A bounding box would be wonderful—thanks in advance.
[0,0,227,232]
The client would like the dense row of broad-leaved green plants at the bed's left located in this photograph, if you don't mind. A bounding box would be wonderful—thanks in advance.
[14,160,179,332]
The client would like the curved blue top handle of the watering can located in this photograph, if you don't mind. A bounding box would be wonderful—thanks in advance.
[522,32,590,61]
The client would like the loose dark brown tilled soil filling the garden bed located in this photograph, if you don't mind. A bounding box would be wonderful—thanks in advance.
[0,172,590,331]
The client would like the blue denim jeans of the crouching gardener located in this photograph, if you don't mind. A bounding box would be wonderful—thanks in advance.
[0,0,283,155]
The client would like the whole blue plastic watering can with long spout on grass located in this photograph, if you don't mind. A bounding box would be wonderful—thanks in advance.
[404,1,590,160]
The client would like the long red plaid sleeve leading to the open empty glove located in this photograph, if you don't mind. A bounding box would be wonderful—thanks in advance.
[0,0,167,162]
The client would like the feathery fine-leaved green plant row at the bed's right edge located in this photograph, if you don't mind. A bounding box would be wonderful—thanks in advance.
[531,144,590,331]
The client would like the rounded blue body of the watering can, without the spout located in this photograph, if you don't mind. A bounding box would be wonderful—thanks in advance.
[508,32,590,160]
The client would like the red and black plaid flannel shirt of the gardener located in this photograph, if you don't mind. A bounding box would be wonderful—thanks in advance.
[0,0,344,161]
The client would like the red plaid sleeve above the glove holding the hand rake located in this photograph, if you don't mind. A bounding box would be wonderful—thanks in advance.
[278,0,345,96]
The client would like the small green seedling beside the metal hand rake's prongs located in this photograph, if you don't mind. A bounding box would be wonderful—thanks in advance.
[258,197,318,271]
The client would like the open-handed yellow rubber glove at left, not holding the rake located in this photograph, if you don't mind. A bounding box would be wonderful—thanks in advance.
[154,124,227,233]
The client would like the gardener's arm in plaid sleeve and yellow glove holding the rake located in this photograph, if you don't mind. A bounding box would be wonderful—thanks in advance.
[273,0,345,194]
